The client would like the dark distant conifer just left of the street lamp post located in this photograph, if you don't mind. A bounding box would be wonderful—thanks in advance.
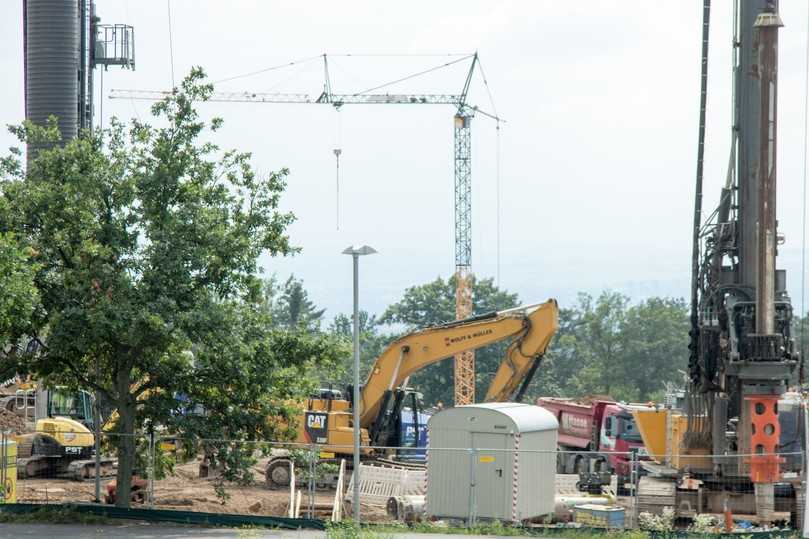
[263,275,326,331]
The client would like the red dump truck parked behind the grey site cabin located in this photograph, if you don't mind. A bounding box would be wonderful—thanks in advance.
[537,397,646,477]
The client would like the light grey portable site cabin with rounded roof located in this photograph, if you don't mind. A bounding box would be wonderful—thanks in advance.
[427,402,559,522]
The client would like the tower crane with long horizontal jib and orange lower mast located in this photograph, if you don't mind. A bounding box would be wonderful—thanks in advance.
[110,52,503,405]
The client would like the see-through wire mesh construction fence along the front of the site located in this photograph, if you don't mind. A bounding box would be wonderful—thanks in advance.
[0,432,805,532]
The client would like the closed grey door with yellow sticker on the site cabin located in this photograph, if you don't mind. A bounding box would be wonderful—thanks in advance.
[472,432,511,518]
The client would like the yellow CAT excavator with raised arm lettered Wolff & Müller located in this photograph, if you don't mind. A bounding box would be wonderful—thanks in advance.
[266,299,559,488]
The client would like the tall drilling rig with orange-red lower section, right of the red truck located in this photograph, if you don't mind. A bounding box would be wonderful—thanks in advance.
[637,0,802,523]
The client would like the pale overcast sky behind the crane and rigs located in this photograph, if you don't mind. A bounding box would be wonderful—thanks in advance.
[0,0,809,317]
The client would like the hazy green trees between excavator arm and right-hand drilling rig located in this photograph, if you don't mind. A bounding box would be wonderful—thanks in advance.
[530,291,688,401]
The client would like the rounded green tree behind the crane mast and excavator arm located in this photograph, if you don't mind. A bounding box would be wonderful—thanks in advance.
[379,276,519,405]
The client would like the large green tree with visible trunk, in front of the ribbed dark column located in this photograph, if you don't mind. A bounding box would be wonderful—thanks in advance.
[0,69,319,506]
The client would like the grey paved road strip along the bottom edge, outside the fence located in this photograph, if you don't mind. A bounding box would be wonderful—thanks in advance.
[0,522,532,539]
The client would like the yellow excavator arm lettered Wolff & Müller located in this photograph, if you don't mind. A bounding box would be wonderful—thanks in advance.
[360,300,559,428]
